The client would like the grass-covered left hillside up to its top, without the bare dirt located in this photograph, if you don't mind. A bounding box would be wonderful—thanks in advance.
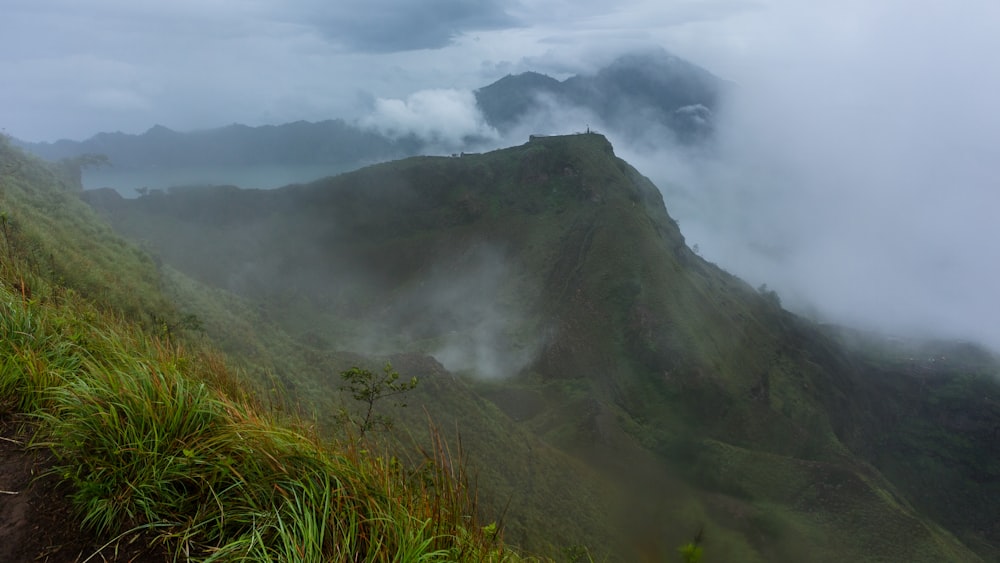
[0,134,540,561]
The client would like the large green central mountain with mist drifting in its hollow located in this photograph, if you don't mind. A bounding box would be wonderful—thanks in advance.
[85,134,1000,562]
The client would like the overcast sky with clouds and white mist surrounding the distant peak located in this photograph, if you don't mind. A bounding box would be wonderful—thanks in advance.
[0,0,1000,349]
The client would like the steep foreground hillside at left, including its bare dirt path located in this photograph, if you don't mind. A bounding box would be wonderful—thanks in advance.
[0,136,544,563]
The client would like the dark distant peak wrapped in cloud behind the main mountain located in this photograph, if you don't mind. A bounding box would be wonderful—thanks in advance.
[476,50,732,143]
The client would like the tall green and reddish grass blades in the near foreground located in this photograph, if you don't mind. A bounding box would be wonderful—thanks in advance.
[0,281,532,561]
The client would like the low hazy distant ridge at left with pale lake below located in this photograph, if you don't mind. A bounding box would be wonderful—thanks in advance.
[12,119,423,195]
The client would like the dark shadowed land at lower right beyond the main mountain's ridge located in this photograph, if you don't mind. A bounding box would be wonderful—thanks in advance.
[837,332,1000,560]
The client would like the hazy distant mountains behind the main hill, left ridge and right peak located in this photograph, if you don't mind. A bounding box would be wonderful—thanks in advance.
[17,50,728,187]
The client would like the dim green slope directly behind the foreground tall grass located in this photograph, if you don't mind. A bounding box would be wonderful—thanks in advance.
[151,239,628,556]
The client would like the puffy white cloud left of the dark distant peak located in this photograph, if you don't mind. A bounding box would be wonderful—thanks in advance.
[361,90,497,149]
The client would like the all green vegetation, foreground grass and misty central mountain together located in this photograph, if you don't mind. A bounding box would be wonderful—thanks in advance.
[0,130,1000,563]
